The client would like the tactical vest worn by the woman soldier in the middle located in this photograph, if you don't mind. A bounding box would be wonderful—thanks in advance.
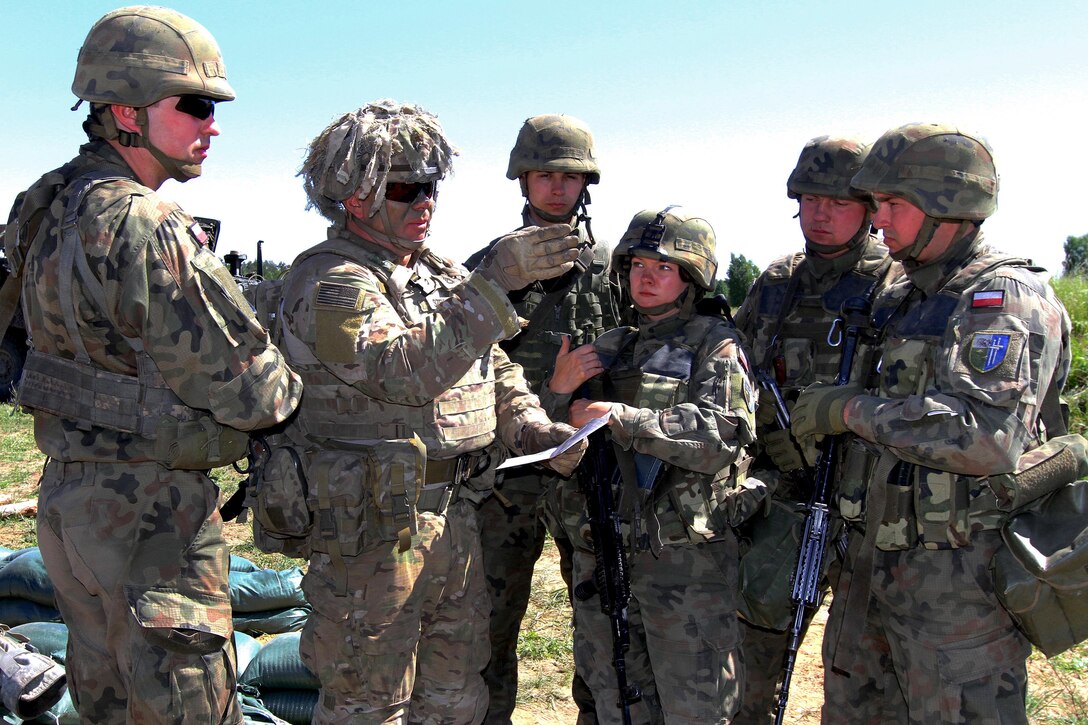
[589,316,752,551]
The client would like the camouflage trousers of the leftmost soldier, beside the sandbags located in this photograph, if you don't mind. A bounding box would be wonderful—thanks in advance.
[37,460,242,725]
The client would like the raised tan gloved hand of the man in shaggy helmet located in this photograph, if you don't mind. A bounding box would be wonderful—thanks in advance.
[477,224,579,292]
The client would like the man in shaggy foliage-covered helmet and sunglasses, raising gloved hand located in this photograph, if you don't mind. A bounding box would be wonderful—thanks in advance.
[281,100,584,723]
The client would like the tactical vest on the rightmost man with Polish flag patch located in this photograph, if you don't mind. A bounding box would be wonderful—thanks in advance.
[840,253,1064,551]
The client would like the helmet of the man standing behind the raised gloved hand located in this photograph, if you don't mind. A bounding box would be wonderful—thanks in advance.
[506,113,601,184]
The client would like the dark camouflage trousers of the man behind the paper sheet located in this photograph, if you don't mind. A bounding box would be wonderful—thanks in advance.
[477,471,596,725]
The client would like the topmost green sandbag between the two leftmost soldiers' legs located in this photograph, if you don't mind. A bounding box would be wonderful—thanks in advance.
[231,556,310,635]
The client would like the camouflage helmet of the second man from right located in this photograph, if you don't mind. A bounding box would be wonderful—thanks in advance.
[786,136,873,205]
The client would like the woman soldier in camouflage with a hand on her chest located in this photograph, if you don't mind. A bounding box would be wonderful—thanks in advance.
[543,207,768,725]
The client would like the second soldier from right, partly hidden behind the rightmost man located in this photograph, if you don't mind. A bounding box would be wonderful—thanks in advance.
[733,136,899,723]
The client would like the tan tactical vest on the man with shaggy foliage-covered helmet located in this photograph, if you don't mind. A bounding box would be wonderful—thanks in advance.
[280,238,497,459]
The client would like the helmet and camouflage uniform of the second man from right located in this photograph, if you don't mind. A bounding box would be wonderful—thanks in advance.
[733,136,898,723]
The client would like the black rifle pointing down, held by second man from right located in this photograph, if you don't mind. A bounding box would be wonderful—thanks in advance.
[758,297,871,725]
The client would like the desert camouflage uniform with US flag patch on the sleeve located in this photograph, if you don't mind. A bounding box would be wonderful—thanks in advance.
[283,226,549,724]
